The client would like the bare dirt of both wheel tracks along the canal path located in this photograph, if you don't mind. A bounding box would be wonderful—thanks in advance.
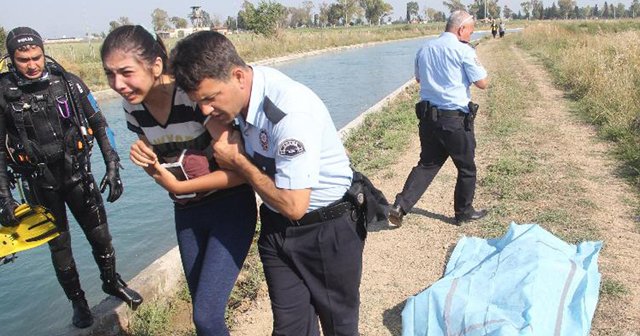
[232,40,640,336]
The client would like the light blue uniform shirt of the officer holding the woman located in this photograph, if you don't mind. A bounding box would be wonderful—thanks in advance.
[238,66,352,211]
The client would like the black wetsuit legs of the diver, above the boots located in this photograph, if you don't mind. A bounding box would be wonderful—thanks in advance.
[30,166,113,300]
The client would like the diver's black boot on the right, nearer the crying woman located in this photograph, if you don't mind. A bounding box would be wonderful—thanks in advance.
[94,250,142,310]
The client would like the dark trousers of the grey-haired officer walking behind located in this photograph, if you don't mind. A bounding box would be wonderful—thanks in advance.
[395,116,476,217]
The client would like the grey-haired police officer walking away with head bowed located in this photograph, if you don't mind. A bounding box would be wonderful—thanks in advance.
[389,11,488,226]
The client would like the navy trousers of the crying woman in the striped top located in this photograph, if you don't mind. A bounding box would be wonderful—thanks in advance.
[175,187,257,336]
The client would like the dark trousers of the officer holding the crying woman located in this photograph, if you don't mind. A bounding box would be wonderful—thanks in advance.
[258,204,364,336]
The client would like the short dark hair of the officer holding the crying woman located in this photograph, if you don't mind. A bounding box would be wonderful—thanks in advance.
[169,31,247,92]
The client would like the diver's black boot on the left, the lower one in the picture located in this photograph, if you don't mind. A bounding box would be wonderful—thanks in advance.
[56,262,93,328]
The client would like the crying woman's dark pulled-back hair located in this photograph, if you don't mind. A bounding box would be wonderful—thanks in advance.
[100,25,169,73]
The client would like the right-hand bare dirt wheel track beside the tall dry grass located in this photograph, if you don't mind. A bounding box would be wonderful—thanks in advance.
[500,43,640,336]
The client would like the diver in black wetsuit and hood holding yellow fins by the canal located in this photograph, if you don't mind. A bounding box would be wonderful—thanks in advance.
[0,27,142,328]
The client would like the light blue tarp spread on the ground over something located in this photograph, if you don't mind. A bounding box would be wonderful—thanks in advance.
[402,223,602,336]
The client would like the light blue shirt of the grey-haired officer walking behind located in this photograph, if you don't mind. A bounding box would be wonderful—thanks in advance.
[415,32,487,113]
